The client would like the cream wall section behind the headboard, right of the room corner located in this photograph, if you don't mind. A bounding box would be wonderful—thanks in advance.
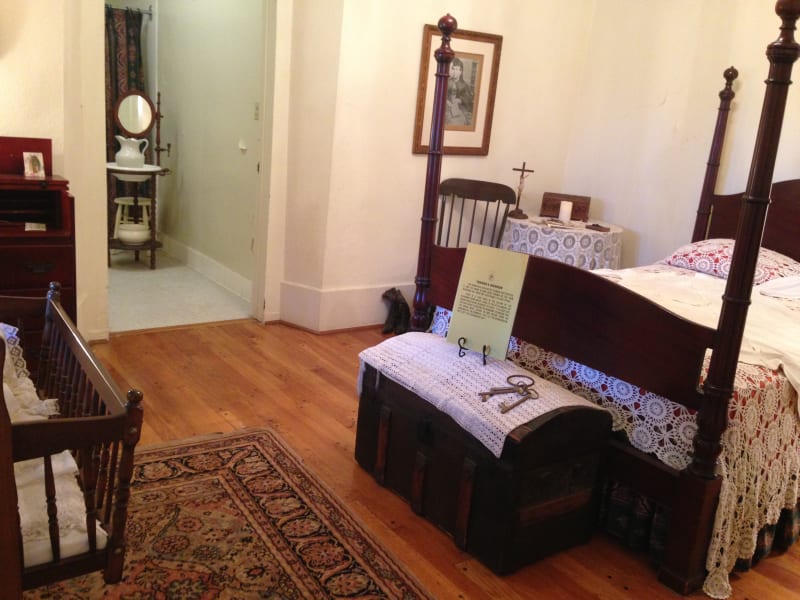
[562,0,800,266]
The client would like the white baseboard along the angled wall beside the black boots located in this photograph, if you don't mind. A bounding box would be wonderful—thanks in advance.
[280,281,415,333]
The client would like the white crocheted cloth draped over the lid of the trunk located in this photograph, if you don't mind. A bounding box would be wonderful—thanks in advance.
[359,332,598,458]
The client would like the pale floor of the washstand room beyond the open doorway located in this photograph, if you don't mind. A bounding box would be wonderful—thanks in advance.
[108,250,251,333]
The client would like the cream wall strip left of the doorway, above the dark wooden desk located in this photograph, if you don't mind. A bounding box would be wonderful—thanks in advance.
[0,0,108,338]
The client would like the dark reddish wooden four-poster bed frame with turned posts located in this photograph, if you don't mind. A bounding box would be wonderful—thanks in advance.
[412,0,800,593]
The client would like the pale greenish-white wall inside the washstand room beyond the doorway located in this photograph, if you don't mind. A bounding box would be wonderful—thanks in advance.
[158,0,270,298]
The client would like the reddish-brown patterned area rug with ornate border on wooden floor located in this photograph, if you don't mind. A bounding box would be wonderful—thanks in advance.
[25,429,430,600]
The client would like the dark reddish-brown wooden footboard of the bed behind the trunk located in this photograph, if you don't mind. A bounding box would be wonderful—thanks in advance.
[428,246,721,593]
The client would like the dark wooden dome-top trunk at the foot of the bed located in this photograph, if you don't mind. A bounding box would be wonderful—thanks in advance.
[355,364,611,574]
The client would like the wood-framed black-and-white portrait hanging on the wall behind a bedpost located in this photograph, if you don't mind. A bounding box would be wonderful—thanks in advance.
[413,25,503,156]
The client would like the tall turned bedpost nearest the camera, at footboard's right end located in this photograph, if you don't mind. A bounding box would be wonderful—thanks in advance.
[659,0,800,593]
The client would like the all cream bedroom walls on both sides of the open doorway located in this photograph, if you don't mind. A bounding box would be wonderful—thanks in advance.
[0,0,800,337]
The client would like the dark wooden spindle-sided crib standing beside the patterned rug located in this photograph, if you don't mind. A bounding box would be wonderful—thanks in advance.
[0,283,142,597]
